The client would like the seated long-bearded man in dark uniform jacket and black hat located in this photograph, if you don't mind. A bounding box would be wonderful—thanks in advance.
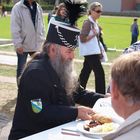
[9,1,103,140]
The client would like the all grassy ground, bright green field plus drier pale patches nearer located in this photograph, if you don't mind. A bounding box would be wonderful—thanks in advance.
[0,13,129,118]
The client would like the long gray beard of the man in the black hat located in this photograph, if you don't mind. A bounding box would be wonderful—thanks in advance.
[51,54,78,96]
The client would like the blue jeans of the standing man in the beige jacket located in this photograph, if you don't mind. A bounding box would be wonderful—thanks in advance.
[17,52,35,79]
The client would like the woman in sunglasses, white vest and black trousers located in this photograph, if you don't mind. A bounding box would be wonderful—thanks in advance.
[79,2,105,94]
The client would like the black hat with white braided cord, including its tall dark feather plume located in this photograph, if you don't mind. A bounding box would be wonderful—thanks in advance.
[46,0,87,48]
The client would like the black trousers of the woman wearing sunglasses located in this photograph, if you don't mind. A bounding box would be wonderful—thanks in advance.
[79,55,105,94]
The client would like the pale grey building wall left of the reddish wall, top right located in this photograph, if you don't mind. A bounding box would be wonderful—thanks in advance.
[88,0,122,12]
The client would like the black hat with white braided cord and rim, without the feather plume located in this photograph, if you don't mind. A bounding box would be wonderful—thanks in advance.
[47,20,80,48]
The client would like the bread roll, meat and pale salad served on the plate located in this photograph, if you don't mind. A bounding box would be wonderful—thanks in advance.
[83,114,119,133]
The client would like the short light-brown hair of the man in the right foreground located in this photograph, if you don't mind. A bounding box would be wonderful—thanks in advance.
[111,52,140,103]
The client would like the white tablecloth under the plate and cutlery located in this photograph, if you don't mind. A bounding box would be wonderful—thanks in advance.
[22,98,123,140]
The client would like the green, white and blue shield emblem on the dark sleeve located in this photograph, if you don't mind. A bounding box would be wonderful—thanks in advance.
[31,99,42,113]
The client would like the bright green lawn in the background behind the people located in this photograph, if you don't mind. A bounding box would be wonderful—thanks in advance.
[0,15,140,49]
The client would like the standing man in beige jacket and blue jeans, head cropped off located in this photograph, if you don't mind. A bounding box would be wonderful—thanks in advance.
[11,0,45,82]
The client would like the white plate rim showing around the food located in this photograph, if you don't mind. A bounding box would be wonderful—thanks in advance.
[77,121,119,138]
